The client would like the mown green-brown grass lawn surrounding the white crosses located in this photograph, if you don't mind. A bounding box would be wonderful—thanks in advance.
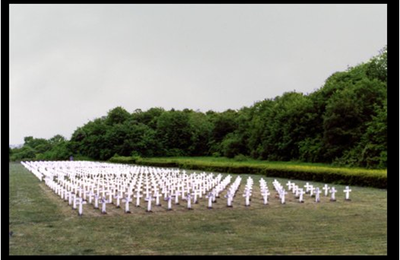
[9,163,387,255]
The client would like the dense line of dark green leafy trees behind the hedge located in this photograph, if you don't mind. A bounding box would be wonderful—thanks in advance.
[10,47,387,168]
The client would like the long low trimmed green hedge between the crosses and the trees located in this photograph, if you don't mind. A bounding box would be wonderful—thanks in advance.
[110,156,387,189]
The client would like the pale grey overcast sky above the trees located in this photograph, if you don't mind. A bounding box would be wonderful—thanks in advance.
[9,4,387,144]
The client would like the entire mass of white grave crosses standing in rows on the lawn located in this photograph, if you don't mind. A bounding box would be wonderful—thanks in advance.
[23,161,351,215]
